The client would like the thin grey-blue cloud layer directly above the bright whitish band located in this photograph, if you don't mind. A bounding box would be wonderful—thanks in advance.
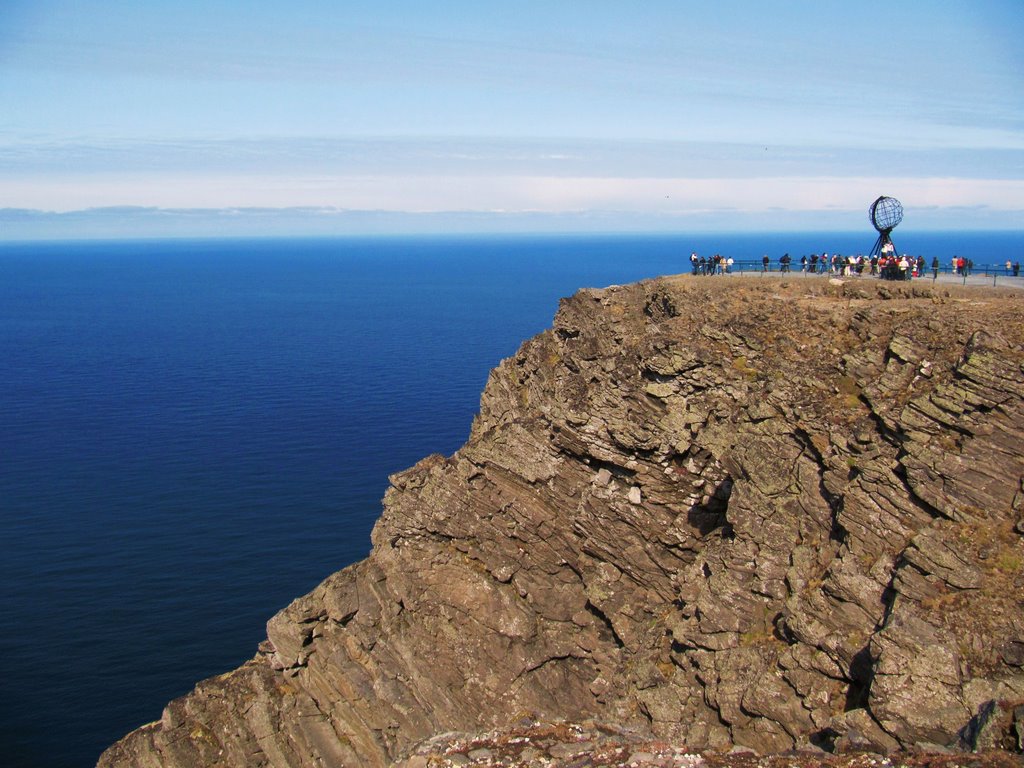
[0,136,1024,181]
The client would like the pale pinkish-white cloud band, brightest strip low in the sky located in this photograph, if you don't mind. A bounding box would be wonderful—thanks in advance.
[0,161,1024,215]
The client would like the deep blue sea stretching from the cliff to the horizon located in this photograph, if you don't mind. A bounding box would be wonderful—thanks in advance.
[0,230,1024,768]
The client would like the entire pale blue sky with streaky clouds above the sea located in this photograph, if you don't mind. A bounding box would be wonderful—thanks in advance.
[0,0,1024,241]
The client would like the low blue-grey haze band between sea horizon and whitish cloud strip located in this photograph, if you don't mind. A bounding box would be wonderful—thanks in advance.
[0,206,1021,241]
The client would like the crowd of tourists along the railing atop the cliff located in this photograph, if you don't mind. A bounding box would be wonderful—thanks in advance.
[690,249,1021,280]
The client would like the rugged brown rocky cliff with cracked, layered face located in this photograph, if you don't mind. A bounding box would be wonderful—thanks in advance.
[100,278,1024,766]
